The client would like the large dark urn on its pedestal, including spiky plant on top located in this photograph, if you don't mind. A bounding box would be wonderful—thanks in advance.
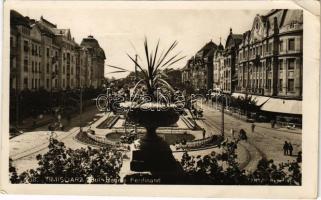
[120,39,183,184]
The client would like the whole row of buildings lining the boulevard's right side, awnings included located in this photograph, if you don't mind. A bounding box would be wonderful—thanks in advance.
[182,10,303,124]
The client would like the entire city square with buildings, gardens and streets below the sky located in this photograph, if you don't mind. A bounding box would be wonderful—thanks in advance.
[9,9,303,185]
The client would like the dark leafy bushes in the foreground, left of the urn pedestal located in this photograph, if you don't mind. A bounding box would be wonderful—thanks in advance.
[10,139,122,183]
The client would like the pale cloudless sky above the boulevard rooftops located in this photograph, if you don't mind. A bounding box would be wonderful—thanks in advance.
[14,6,267,78]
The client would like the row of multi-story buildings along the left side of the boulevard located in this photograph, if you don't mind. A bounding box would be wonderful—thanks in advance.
[10,10,106,92]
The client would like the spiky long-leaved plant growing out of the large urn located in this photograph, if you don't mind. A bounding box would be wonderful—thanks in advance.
[109,38,185,100]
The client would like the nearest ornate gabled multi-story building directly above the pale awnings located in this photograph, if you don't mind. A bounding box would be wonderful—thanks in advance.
[236,10,303,99]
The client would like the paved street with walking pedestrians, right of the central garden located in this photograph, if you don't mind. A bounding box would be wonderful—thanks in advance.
[199,102,302,171]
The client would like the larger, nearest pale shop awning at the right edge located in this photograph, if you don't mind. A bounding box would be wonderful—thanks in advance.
[261,98,302,115]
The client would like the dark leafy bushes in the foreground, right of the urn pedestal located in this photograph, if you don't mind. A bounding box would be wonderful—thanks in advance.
[181,141,302,185]
